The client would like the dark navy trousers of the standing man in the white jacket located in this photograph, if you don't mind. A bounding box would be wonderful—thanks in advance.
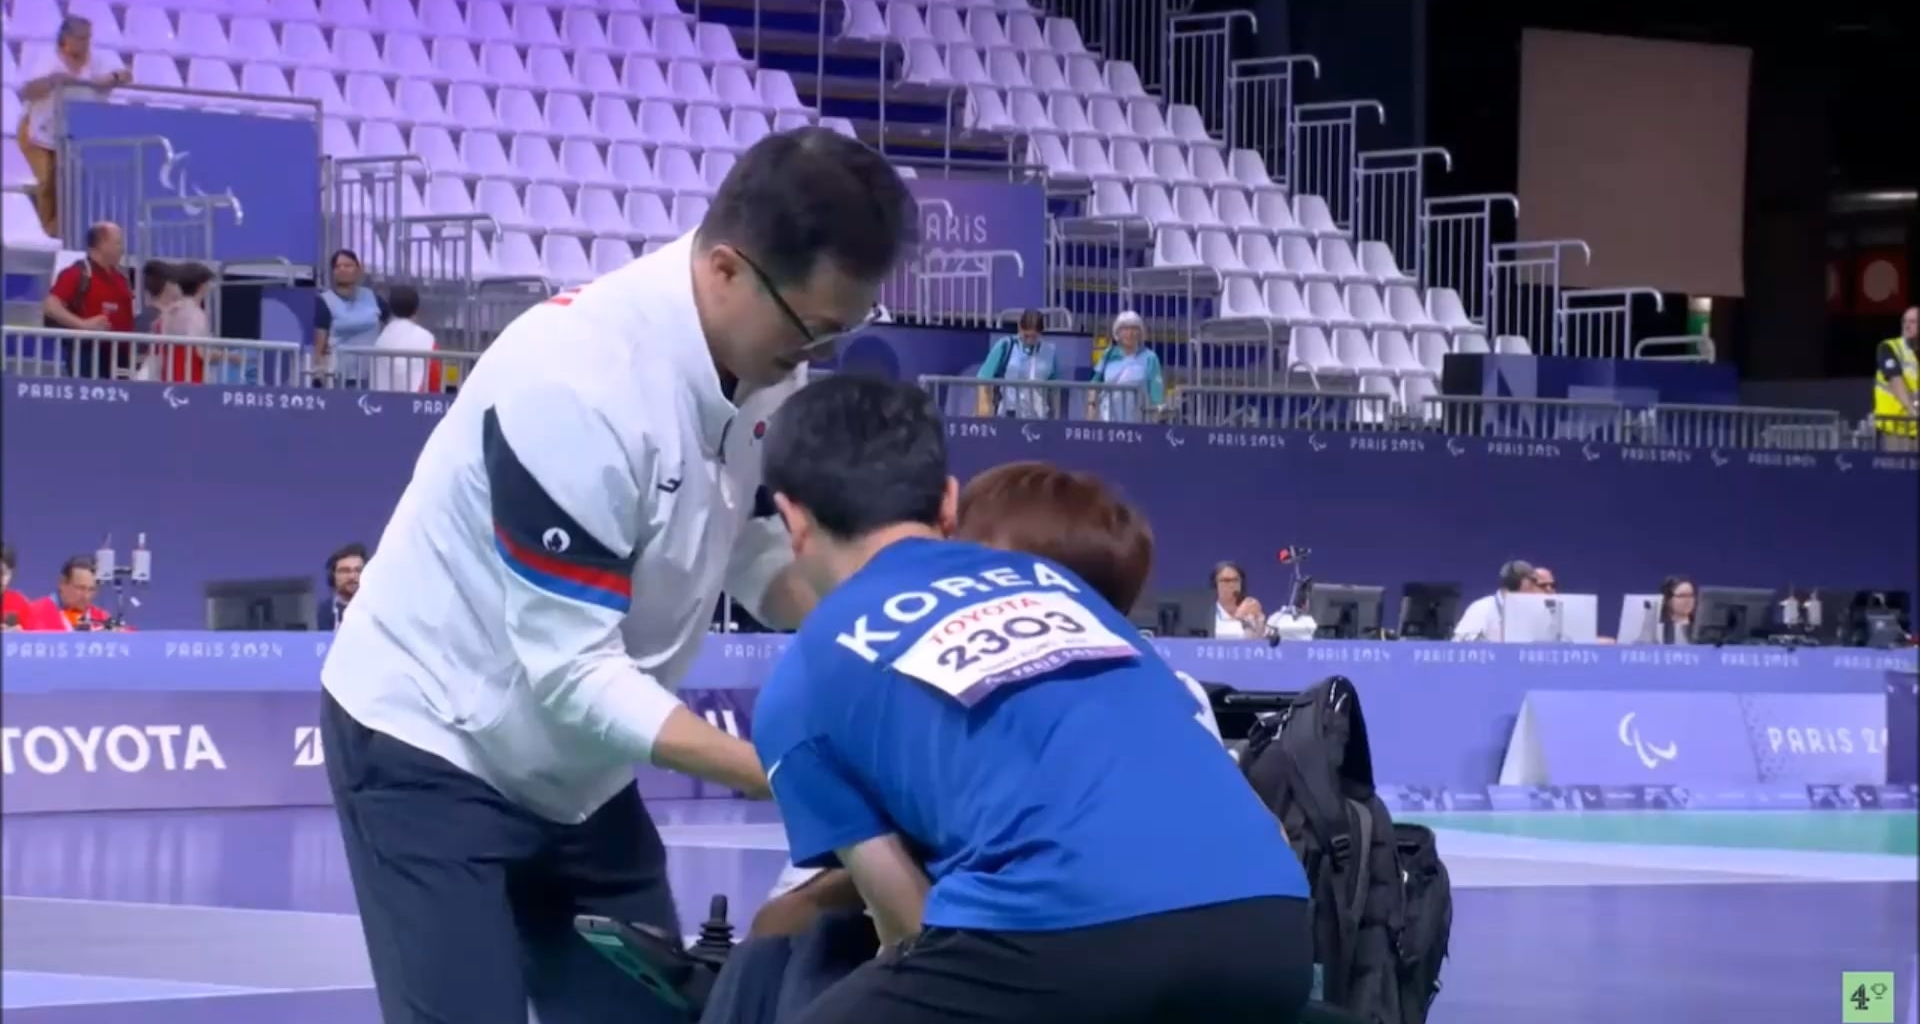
[321,697,680,1024]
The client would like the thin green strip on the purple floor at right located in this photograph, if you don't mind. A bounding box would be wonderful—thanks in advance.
[1394,811,1920,857]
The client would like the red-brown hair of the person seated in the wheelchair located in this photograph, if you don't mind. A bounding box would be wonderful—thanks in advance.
[956,463,1154,615]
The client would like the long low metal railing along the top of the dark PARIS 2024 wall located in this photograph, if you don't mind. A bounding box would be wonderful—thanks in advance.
[0,327,1889,455]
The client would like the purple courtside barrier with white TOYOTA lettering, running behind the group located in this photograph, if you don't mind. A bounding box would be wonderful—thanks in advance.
[0,632,1914,813]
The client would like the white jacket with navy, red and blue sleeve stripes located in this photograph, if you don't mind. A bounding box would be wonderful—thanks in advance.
[321,236,799,822]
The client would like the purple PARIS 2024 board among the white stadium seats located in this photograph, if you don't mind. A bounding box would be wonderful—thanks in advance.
[906,177,1046,313]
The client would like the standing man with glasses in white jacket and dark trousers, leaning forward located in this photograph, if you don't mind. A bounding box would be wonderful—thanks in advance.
[321,129,916,1024]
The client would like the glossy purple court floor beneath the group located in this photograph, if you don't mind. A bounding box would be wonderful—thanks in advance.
[0,803,1920,1024]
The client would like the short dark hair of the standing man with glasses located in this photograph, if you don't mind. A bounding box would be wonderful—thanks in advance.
[699,127,920,286]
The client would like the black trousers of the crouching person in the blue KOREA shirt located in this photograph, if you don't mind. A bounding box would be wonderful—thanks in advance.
[797,899,1313,1024]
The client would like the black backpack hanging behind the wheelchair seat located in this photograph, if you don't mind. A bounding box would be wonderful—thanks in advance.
[1240,676,1453,1024]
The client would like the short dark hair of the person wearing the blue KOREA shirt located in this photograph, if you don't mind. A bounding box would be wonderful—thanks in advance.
[760,373,947,540]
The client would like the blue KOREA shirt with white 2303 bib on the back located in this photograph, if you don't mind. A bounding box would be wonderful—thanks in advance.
[755,540,1308,932]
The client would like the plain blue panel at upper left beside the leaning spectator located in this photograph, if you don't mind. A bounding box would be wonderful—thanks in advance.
[65,100,321,263]
